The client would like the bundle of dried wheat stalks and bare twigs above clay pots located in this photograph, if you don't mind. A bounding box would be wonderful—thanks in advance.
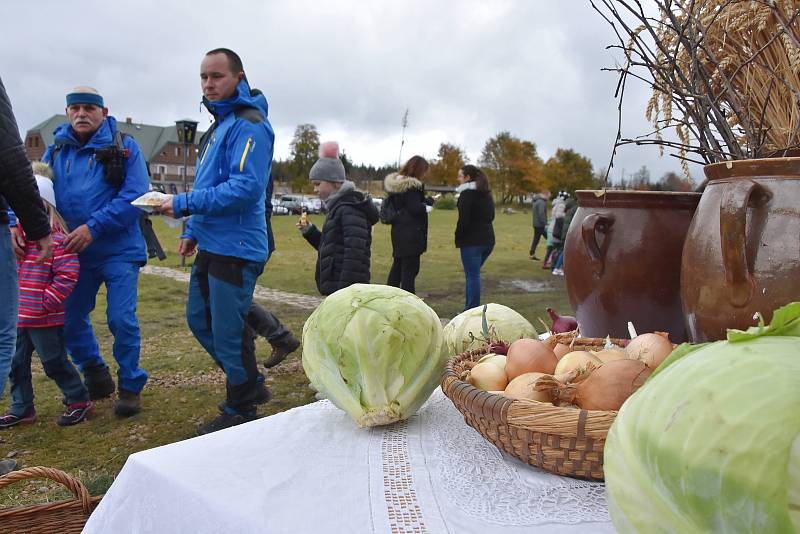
[592,0,800,180]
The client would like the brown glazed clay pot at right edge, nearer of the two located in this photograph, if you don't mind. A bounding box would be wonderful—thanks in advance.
[681,158,800,342]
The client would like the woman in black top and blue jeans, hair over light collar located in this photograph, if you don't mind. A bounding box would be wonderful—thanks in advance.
[456,165,494,310]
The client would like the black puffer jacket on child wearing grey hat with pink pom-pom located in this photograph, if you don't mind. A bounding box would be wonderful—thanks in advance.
[303,190,378,295]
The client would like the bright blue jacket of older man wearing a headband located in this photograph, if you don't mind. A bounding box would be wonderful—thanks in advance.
[42,116,150,265]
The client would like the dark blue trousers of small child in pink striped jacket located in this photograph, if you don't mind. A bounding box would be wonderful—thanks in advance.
[9,326,89,417]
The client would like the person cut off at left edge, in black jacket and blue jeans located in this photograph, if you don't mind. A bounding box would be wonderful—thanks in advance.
[0,79,53,397]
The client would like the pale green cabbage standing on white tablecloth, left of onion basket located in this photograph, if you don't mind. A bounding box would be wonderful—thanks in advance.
[303,284,447,427]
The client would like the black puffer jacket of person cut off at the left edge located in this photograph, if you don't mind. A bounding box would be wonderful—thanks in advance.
[0,79,50,241]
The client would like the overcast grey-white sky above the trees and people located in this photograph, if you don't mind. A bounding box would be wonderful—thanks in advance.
[0,0,698,180]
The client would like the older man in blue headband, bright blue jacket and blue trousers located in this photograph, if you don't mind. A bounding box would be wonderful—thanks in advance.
[35,87,149,417]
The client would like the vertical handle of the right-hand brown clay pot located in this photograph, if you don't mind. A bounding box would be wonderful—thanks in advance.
[719,180,766,308]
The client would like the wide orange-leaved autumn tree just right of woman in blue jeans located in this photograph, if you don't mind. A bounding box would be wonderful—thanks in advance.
[479,132,544,203]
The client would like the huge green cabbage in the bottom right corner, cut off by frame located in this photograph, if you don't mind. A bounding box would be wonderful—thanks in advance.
[604,303,800,534]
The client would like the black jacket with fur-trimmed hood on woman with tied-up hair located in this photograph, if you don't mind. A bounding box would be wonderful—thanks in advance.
[382,173,428,258]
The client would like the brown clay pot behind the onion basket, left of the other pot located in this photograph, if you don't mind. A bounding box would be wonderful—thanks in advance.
[564,191,700,343]
